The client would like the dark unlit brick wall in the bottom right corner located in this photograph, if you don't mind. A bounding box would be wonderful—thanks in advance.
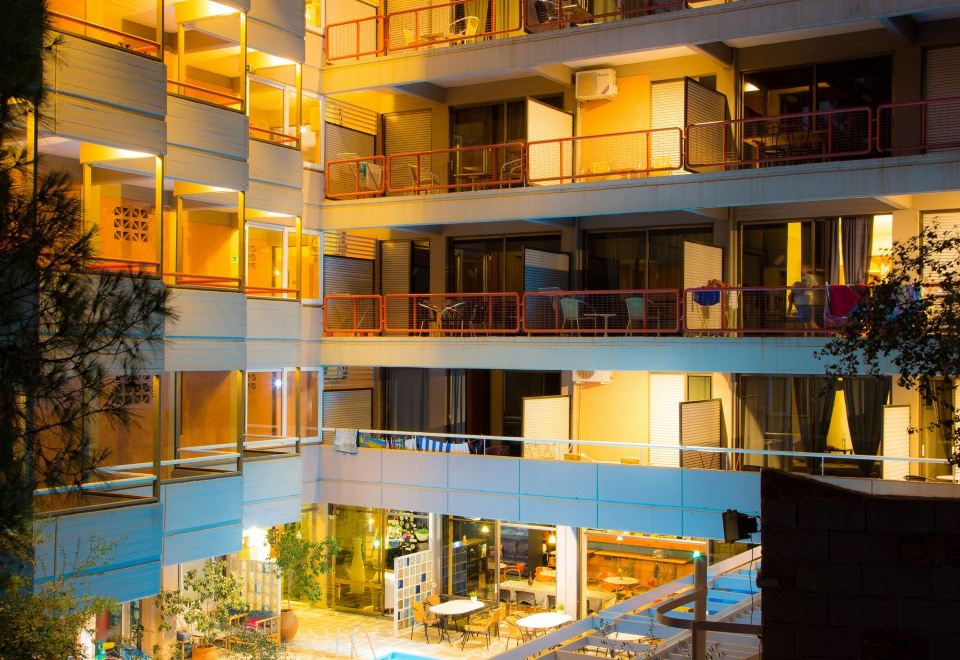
[758,470,960,660]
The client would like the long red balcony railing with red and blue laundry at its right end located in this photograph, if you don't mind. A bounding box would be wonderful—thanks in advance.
[324,285,868,338]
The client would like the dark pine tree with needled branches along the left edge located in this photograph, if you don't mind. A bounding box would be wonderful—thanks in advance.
[0,0,173,564]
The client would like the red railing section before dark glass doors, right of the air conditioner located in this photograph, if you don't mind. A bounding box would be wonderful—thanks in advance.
[685,107,873,169]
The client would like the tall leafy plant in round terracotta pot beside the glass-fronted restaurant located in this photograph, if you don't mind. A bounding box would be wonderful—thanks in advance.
[267,523,340,642]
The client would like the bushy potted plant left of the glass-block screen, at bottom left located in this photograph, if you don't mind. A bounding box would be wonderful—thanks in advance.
[156,559,247,660]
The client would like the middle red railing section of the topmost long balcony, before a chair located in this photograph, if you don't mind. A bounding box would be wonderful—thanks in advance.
[384,0,523,53]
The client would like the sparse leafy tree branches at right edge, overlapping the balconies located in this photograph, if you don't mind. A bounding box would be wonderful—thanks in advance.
[818,226,960,464]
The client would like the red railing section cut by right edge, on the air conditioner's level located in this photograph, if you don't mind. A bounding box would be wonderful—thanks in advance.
[877,96,960,153]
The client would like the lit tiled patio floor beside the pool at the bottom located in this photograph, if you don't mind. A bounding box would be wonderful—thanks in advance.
[287,603,506,660]
